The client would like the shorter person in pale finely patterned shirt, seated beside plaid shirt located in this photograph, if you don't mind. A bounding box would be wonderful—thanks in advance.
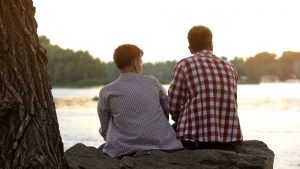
[98,44,182,157]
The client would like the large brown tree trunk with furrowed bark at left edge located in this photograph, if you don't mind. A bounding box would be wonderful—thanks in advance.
[0,0,68,169]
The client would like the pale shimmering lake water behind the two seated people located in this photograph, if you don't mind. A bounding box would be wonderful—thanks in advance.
[52,83,300,169]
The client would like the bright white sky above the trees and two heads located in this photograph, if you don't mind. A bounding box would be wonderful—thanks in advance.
[33,0,300,62]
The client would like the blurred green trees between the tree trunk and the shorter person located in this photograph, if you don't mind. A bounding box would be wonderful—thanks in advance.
[39,36,104,87]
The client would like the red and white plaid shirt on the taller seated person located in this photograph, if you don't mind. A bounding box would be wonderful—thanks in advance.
[168,50,243,142]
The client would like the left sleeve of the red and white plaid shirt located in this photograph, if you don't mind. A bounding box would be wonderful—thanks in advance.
[168,63,186,123]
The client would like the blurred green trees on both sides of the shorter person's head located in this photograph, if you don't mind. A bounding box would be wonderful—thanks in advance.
[39,36,176,87]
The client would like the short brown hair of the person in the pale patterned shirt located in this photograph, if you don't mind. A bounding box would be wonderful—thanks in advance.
[114,44,144,69]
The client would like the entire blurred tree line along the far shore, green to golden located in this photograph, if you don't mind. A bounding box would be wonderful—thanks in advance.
[40,36,300,87]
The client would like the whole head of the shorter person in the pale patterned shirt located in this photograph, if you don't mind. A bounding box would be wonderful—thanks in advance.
[114,44,144,73]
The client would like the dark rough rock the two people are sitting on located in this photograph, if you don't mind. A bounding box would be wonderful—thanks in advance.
[65,140,274,169]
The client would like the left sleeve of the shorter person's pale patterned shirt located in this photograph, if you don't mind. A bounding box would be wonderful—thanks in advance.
[97,90,111,141]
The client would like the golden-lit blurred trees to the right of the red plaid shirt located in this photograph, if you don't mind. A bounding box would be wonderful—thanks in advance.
[230,51,300,83]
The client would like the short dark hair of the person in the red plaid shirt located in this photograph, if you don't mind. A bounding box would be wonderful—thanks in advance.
[188,25,212,51]
